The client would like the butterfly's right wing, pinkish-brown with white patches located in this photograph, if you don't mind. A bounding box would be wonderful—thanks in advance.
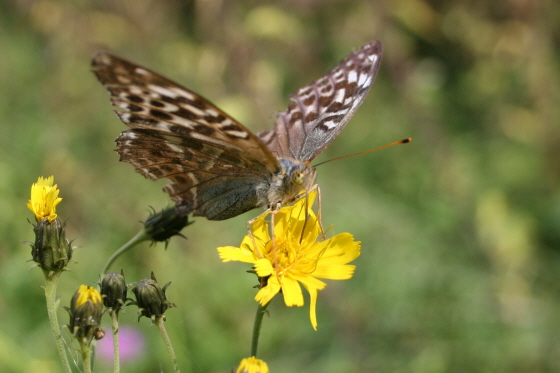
[257,40,382,162]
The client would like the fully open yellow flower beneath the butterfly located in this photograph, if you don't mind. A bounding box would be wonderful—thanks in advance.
[218,192,360,330]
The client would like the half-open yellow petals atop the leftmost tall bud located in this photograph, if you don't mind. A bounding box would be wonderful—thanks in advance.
[27,176,62,223]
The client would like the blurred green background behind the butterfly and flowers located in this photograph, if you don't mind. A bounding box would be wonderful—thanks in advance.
[0,0,560,373]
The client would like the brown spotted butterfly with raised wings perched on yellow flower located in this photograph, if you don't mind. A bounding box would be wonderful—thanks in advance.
[92,41,382,220]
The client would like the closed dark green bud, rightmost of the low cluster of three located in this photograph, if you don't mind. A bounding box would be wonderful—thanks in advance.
[128,272,176,322]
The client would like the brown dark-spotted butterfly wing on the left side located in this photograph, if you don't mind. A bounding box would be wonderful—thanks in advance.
[92,52,281,220]
